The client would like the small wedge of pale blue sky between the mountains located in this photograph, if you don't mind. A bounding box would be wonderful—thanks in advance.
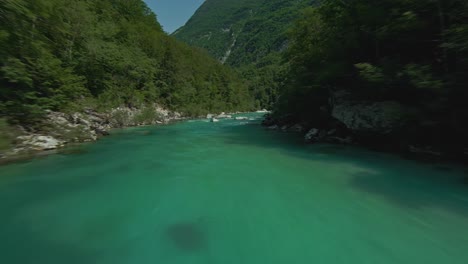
[145,0,205,33]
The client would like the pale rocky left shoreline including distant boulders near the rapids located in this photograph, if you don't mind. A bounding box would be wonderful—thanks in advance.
[0,105,268,165]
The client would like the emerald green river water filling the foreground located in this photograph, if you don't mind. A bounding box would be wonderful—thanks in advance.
[0,115,468,264]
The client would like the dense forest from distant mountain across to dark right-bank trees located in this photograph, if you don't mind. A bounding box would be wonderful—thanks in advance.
[174,0,468,155]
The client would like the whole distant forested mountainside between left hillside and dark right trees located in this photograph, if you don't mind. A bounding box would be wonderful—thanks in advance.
[174,0,315,108]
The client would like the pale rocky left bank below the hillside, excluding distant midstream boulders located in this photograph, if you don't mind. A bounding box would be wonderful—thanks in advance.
[0,105,184,161]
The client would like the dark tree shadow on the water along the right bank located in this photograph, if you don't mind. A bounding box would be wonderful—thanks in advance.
[224,121,468,217]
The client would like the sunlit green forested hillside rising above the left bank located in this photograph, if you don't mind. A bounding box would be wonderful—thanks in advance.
[0,0,252,123]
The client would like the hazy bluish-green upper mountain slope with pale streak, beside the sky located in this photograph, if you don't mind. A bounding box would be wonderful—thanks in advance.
[173,0,314,66]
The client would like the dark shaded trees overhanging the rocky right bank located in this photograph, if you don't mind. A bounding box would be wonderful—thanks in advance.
[276,0,468,152]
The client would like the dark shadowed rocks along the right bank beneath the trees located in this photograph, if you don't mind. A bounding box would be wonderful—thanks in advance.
[262,91,468,161]
